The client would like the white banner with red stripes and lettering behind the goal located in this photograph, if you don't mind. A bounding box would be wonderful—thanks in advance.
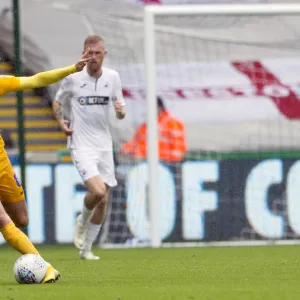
[119,58,300,123]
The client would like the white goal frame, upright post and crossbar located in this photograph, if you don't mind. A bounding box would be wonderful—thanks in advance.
[144,3,300,247]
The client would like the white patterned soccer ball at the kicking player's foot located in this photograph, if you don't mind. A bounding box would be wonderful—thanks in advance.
[14,254,47,284]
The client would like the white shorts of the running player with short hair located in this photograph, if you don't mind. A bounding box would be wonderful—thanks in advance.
[71,149,117,187]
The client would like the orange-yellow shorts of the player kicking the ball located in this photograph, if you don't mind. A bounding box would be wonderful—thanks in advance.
[0,147,25,202]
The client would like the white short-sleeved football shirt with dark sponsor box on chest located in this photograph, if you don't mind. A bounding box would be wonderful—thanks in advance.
[55,68,125,151]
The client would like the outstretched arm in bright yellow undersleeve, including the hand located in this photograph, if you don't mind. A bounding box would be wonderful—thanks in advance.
[20,48,90,90]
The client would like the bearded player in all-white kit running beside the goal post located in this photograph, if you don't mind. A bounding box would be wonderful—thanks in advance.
[53,35,125,260]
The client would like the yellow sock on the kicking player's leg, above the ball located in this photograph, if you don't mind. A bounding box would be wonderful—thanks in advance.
[0,222,39,254]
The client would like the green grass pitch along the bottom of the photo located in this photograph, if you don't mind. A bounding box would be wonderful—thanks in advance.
[0,246,300,300]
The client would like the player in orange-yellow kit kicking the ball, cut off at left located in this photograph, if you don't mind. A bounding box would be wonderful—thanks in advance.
[0,49,90,283]
